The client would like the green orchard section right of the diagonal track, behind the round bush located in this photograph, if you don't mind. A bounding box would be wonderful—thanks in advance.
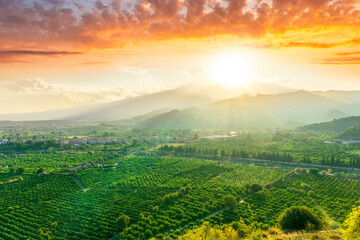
[204,173,360,232]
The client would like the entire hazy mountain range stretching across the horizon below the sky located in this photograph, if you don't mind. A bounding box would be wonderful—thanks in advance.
[0,87,360,129]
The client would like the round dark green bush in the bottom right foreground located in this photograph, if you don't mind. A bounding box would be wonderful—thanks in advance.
[278,207,326,230]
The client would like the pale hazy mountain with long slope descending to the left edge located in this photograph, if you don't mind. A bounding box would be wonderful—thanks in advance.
[0,87,213,120]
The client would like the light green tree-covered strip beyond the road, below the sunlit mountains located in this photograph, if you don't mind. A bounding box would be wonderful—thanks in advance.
[162,132,360,168]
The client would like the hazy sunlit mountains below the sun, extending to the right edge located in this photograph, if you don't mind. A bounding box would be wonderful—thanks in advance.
[143,91,360,129]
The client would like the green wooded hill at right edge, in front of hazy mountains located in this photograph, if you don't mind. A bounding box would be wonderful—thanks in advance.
[300,116,360,133]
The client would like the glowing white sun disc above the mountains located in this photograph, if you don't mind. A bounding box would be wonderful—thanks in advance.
[210,54,250,88]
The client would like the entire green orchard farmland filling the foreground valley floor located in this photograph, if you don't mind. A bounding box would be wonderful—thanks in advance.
[0,156,360,239]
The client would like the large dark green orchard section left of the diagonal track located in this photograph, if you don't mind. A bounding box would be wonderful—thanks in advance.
[0,157,283,239]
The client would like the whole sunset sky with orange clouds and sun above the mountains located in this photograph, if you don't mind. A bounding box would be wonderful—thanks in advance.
[0,0,360,114]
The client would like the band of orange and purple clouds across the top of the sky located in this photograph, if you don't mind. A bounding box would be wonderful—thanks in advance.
[0,0,360,52]
